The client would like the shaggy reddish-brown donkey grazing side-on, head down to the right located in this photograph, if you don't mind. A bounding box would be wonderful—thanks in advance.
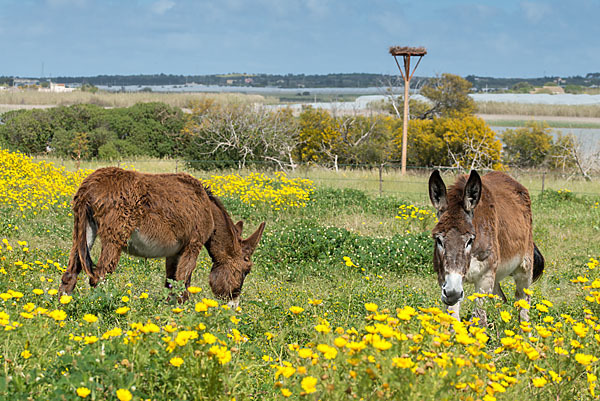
[60,167,265,307]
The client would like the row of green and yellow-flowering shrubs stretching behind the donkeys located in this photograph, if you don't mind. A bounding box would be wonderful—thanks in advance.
[0,101,576,170]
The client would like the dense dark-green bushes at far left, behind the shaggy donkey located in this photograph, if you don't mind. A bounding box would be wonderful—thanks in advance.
[0,103,184,159]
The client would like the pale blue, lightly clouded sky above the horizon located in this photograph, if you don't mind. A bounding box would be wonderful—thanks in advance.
[0,0,600,78]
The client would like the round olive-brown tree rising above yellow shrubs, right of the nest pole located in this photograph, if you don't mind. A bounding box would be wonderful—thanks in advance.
[421,74,475,118]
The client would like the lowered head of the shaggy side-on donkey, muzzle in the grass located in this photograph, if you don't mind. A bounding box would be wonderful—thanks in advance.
[209,221,265,308]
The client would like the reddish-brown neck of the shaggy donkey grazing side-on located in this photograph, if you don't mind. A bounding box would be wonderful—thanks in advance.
[206,197,241,265]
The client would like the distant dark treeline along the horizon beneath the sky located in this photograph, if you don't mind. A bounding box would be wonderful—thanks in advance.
[0,73,600,91]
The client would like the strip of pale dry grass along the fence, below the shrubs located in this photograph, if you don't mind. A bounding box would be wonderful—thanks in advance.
[72,159,600,199]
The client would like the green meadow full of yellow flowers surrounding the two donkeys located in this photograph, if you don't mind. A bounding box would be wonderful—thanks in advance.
[0,150,600,401]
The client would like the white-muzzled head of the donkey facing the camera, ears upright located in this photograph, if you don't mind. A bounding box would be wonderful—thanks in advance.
[429,170,481,306]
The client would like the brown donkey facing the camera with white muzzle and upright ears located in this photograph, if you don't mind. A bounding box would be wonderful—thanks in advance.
[429,170,544,325]
